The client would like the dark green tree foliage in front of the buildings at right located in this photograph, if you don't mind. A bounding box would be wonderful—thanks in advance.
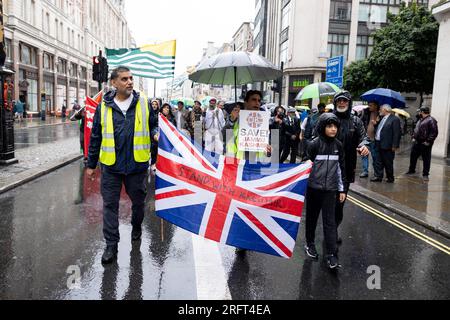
[344,2,439,95]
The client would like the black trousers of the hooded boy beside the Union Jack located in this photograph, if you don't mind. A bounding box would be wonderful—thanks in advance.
[306,188,337,254]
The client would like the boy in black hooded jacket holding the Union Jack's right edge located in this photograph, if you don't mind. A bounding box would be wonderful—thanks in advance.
[305,113,346,269]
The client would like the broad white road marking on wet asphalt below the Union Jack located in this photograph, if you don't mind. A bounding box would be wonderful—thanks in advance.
[192,234,231,300]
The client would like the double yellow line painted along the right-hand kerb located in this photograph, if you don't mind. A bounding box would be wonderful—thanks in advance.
[348,196,450,255]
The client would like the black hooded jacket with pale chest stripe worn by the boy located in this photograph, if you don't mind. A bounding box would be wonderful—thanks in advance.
[307,113,347,192]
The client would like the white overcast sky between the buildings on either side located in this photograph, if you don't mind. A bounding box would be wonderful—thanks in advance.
[125,0,255,93]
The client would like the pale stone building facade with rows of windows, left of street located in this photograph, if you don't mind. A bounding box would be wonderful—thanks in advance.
[3,0,134,115]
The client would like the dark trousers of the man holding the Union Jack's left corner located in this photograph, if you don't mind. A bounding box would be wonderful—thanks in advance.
[101,169,147,245]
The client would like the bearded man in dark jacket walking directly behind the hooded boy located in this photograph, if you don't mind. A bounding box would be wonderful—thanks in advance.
[333,91,370,243]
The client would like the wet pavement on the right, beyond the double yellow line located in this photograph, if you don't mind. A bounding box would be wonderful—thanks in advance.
[350,137,450,238]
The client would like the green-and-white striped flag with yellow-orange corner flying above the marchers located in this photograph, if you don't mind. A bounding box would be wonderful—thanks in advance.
[106,40,176,79]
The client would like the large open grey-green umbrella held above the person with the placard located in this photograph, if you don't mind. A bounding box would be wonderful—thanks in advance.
[189,51,283,99]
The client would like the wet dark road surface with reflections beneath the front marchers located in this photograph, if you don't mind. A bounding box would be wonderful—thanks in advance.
[0,163,450,300]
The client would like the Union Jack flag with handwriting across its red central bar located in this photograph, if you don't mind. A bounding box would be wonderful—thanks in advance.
[155,116,311,258]
